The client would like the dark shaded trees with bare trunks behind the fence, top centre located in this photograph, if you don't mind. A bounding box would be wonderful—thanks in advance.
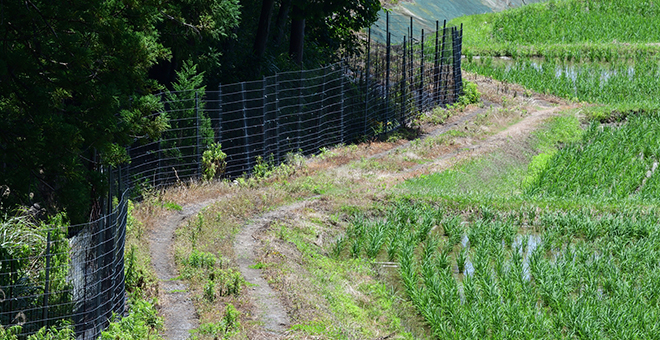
[231,0,381,82]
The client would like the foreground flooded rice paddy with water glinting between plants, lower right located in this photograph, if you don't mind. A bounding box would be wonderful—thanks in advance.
[338,201,660,339]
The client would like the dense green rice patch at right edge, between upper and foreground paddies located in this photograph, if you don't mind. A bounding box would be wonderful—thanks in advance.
[527,112,660,204]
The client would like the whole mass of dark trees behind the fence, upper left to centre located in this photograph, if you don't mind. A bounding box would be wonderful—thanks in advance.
[0,0,372,223]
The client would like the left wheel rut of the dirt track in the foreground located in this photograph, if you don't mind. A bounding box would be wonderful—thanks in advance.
[149,200,218,340]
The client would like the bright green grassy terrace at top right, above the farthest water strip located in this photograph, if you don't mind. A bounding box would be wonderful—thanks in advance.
[450,0,660,61]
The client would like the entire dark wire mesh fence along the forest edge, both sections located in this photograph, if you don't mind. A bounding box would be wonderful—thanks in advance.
[0,15,462,339]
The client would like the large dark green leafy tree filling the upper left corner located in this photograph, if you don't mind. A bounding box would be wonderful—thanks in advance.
[0,0,168,223]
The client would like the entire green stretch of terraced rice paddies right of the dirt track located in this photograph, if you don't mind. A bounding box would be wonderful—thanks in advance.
[333,0,660,339]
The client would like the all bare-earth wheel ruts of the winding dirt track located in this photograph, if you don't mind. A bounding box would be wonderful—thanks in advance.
[150,76,569,339]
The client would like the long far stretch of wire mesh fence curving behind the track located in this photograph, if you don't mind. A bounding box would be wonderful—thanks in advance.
[130,20,462,187]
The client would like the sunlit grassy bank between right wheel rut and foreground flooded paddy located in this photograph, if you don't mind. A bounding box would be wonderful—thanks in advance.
[262,223,420,339]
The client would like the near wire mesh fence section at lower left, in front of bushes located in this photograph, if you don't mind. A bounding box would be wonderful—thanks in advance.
[0,165,127,339]
